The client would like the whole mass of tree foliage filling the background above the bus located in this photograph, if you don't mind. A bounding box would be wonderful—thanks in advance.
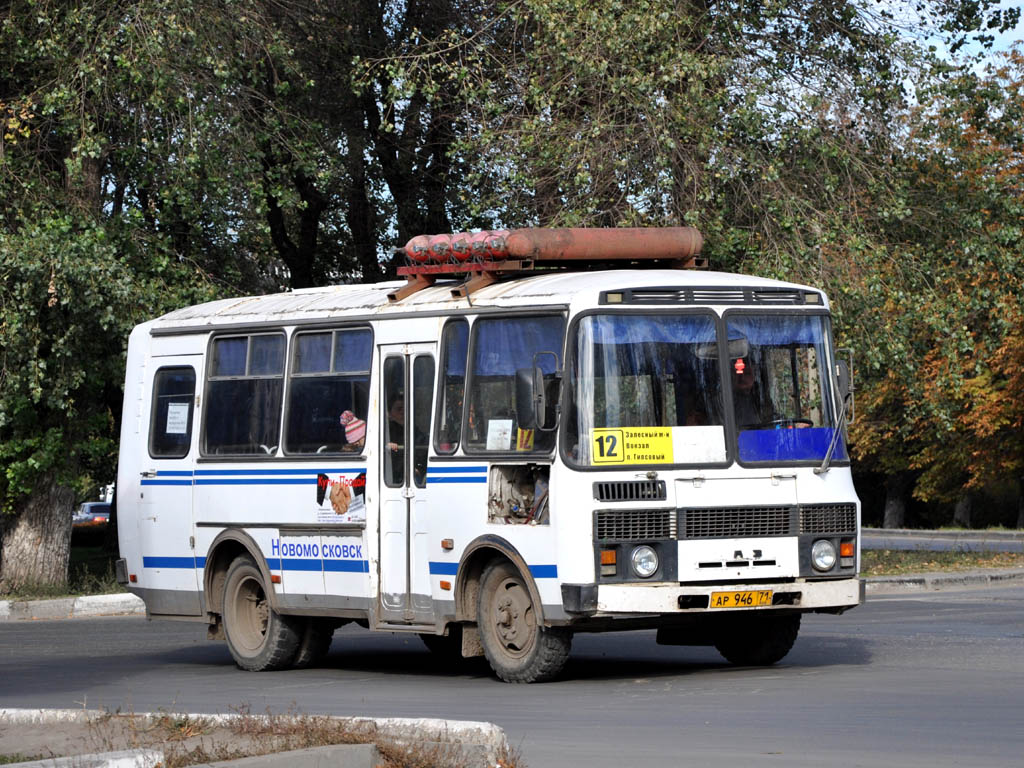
[0,0,1024,528]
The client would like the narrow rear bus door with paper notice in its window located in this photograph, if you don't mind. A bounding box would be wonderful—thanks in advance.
[138,354,203,615]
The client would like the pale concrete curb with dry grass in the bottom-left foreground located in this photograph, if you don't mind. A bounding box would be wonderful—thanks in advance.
[0,709,509,768]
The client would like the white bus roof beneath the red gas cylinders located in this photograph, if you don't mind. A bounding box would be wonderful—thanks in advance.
[151,269,826,332]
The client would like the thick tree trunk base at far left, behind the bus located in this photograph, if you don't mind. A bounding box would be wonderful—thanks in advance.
[0,477,75,594]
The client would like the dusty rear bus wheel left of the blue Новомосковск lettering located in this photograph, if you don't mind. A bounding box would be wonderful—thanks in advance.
[223,555,301,672]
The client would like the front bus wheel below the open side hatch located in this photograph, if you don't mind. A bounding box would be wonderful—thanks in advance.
[476,560,572,683]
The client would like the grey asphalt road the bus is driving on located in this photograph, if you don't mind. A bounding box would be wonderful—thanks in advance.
[0,582,1024,768]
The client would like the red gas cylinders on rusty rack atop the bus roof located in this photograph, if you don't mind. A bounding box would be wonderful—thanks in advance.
[388,226,708,301]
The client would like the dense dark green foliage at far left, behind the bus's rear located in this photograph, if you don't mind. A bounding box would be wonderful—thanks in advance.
[0,213,210,512]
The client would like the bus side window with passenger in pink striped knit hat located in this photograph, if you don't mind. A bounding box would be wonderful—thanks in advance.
[285,328,373,455]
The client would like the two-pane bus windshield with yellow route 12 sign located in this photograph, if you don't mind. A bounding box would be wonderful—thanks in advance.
[565,312,846,467]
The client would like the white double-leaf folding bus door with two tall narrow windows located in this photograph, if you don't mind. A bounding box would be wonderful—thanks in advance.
[378,344,434,624]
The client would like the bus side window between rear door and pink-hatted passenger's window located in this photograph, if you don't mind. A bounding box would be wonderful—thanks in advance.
[203,333,285,455]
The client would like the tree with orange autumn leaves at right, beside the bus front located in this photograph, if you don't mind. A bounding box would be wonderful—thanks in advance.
[857,53,1024,528]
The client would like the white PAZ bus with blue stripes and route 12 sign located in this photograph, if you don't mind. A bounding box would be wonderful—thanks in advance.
[117,228,863,682]
